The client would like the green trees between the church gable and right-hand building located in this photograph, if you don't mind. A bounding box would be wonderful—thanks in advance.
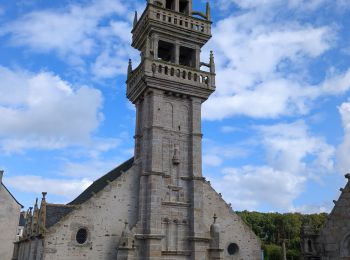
[237,211,327,260]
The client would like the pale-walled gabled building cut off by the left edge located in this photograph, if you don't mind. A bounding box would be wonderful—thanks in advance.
[0,171,23,260]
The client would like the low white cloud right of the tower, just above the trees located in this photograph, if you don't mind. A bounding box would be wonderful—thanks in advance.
[213,166,306,210]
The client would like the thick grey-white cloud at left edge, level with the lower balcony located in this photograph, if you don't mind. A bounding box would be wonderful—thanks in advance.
[0,67,102,152]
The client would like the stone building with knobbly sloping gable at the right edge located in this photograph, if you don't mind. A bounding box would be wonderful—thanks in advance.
[301,173,350,260]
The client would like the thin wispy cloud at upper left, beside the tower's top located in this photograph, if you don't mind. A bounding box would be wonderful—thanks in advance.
[0,0,138,79]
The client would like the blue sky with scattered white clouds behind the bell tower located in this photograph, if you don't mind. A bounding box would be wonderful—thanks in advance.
[0,0,350,213]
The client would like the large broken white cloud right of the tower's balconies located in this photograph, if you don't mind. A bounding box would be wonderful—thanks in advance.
[203,0,350,120]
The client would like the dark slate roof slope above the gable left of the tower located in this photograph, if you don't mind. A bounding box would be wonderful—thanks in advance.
[68,158,134,205]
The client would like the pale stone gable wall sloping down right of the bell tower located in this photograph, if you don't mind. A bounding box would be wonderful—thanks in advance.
[203,182,261,260]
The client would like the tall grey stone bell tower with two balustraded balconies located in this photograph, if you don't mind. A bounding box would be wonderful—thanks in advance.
[127,0,215,260]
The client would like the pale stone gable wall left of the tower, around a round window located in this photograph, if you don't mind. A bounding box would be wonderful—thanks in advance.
[42,168,139,260]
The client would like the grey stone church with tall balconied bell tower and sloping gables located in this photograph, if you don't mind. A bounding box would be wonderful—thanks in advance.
[12,0,261,260]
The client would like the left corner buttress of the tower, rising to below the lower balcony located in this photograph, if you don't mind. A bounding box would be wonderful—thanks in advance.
[136,90,164,260]
